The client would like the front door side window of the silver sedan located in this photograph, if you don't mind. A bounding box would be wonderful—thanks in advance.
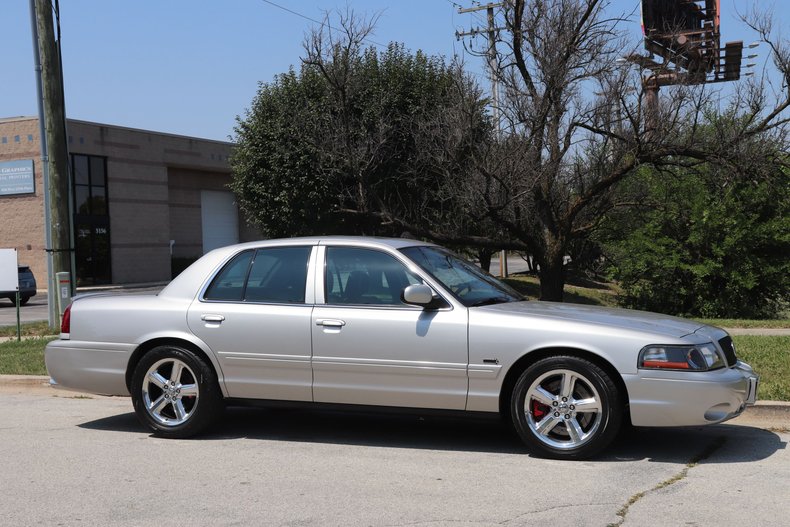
[324,247,422,306]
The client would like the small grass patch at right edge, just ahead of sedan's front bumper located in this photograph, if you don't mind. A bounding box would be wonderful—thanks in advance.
[732,335,790,401]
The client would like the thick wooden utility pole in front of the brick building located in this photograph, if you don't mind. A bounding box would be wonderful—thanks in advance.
[30,0,73,328]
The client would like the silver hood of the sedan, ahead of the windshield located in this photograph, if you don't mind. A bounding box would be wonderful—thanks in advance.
[472,301,703,338]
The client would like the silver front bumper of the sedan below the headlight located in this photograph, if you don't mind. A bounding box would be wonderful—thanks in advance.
[623,361,760,426]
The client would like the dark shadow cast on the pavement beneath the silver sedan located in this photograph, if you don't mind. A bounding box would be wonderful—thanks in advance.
[79,407,786,464]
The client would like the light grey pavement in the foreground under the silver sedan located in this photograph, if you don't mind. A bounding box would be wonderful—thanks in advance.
[0,385,790,527]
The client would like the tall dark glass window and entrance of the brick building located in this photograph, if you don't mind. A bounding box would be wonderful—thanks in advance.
[71,154,112,286]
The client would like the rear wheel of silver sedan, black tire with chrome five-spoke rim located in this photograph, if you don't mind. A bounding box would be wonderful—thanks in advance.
[131,345,224,439]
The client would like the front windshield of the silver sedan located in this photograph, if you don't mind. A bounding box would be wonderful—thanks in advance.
[401,247,524,307]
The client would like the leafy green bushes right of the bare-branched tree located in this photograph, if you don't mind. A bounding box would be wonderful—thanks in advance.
[606,159,790,318]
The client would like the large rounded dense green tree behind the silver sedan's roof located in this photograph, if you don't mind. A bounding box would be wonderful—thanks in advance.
[231,13,491,237]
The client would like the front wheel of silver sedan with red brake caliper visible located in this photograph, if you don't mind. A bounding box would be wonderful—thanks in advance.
[510,355,623,459]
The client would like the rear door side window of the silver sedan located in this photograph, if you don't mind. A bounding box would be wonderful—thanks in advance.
[204,247,311,304]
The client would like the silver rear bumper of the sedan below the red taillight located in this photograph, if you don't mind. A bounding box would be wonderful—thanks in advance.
[44,340,134,395]
